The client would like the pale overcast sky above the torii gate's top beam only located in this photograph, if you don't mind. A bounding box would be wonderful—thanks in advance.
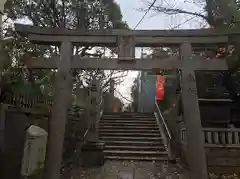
[115,0,202,29]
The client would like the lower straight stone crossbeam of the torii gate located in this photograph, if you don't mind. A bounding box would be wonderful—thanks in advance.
[25,55,228,71]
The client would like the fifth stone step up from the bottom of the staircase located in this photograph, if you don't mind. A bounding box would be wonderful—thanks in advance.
[100,136,162,141]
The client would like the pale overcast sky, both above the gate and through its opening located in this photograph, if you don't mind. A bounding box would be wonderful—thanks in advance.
[115,0,203,102]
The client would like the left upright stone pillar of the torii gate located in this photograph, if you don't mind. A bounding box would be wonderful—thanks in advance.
[44,42,73,179]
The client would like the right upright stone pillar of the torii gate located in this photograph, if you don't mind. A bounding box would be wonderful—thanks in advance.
[180,42,208,179]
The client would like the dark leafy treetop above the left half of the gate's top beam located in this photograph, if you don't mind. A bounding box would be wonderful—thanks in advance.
[6,0,127,29]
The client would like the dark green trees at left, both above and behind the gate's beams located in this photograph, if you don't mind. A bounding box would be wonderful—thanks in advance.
[0,0,128,100]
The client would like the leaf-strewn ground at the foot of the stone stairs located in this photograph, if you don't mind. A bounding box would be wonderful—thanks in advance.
[63,161,188,179]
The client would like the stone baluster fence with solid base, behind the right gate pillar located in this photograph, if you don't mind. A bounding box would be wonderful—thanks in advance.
[180,128,240,167]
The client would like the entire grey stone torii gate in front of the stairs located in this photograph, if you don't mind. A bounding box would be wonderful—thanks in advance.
[15,24,229,179]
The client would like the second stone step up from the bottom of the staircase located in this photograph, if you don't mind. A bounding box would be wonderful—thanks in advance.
[104,150,167,157]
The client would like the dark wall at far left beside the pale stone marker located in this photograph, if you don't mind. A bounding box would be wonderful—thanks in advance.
[0,111,27,179]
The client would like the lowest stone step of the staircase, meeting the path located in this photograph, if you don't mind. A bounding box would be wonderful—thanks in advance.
[104,156,168,161]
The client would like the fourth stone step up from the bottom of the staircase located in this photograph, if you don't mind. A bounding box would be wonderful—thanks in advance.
[102,140,163,146]
